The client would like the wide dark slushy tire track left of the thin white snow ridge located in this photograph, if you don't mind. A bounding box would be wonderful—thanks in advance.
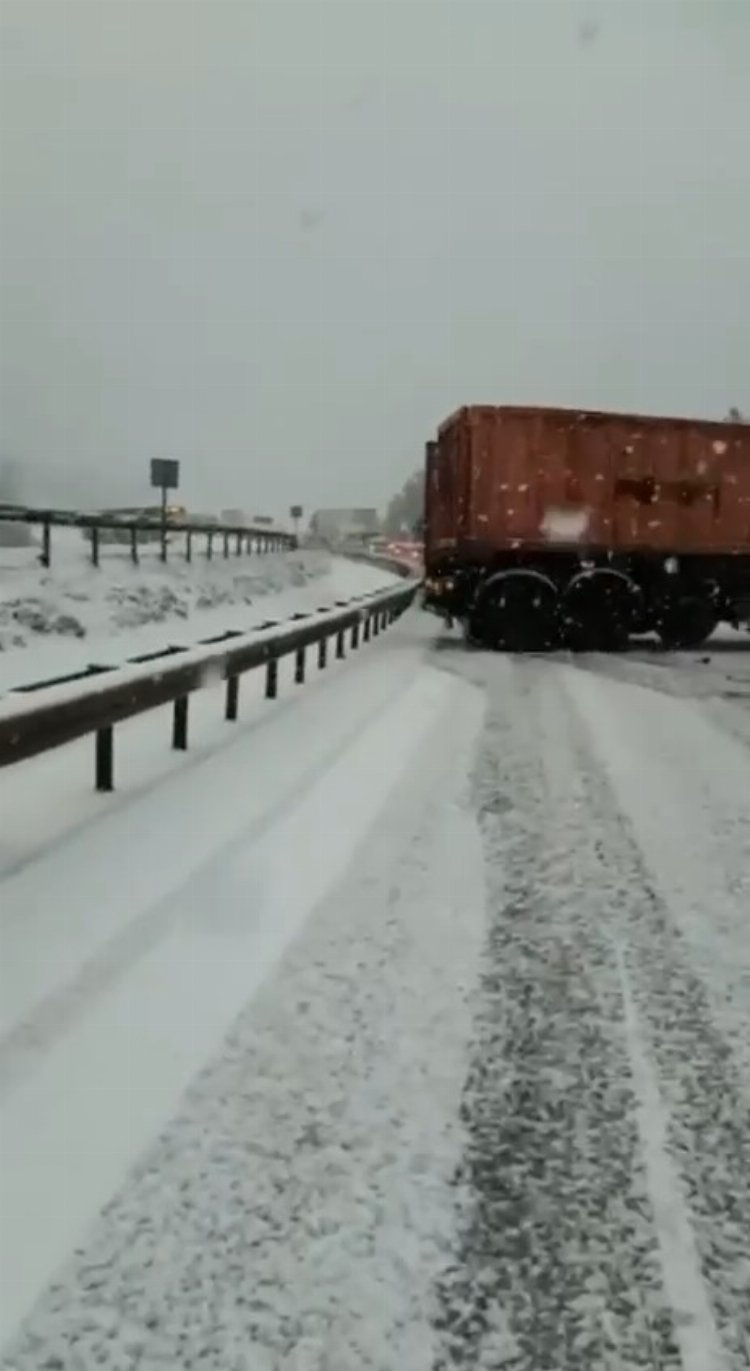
[436,661,680,1371]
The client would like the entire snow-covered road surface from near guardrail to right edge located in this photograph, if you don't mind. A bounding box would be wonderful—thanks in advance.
[0,611,750,1371]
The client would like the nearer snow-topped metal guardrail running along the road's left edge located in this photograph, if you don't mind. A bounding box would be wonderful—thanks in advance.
[0,579,420,791]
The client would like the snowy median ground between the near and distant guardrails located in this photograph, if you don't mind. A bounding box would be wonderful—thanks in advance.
[0,551,396,692]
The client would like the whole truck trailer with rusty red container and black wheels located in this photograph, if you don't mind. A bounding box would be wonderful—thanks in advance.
[424,406,750,651]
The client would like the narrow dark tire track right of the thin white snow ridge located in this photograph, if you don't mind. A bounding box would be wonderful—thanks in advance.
[570,677,750,1371]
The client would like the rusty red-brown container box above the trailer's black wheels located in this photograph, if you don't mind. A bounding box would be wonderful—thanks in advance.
[428,406,750,554]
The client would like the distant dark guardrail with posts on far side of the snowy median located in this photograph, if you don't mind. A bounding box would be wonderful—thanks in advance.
[0,505,298,566]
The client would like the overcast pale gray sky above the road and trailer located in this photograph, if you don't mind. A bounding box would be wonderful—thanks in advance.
[0,0,750,513]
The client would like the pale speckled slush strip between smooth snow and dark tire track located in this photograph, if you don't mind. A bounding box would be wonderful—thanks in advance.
[3,666,485,1371]
